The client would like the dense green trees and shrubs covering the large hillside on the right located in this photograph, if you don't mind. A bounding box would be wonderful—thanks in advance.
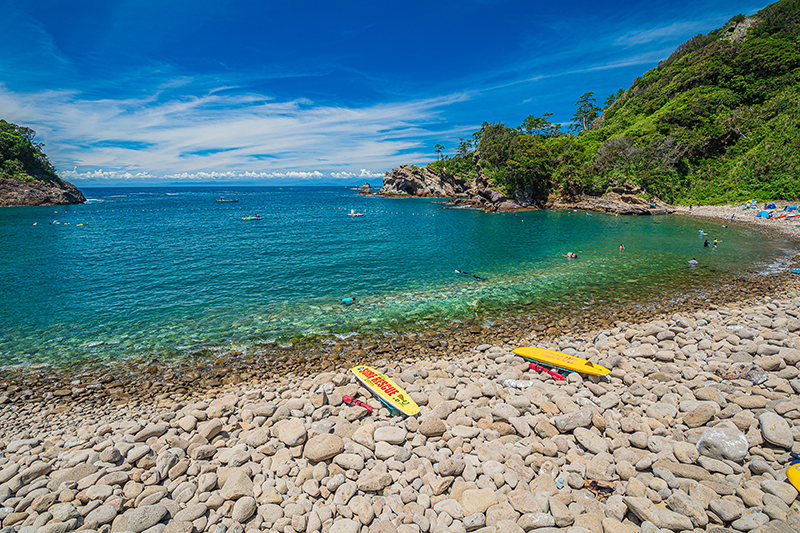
[428,0,800,203]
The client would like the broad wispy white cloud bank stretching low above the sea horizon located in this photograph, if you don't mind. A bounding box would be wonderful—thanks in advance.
[0,85,466,182]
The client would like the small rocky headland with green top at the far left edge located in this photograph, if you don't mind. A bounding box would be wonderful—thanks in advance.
[0,120,86,207]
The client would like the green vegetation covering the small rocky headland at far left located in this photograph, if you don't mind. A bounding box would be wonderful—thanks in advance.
[0,119,61,183]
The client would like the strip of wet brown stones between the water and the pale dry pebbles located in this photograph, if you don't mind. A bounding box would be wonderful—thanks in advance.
[0,254,800,409]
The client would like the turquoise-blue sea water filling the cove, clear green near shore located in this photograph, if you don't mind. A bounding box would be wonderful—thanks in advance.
[0,187,787,366]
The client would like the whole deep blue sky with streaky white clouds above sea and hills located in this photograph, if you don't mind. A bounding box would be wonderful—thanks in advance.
[0,0,766,186]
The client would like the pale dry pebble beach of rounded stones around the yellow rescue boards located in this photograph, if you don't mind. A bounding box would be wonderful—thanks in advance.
[0,207,800,533]
